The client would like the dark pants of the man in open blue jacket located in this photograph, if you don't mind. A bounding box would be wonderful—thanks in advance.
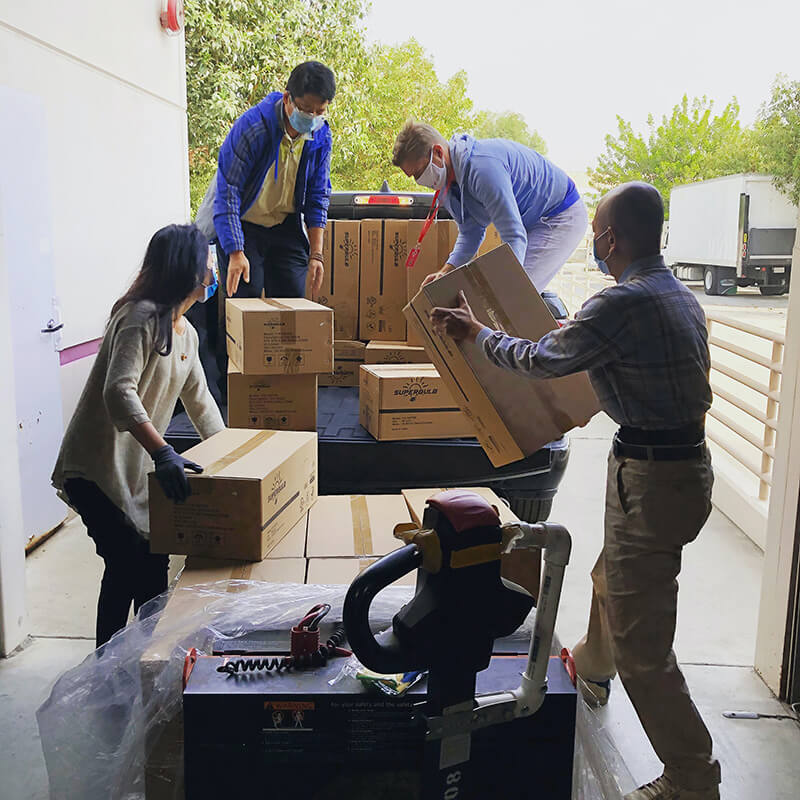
[217,214,309,397]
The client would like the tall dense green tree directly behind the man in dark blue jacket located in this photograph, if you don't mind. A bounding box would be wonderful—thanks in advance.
[186,0,371,211]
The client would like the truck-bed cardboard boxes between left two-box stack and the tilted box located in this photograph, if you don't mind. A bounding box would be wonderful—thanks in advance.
[308,219,488,440]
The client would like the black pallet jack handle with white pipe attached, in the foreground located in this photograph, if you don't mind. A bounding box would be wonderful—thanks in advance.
[343,490,571,800]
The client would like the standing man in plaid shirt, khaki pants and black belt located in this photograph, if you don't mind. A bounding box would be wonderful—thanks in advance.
[431,183,720,800]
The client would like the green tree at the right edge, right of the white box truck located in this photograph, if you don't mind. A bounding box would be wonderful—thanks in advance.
[756,75,800,203]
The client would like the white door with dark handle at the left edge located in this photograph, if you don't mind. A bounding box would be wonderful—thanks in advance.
[0,87,66,545]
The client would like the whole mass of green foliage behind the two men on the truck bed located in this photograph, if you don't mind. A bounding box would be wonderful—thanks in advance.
[186,5,545,211]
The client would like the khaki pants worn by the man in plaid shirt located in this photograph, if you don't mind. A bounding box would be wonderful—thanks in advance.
[574,446,720,790]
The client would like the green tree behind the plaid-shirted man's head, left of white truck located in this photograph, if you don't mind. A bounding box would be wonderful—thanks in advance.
[589,95,763,214]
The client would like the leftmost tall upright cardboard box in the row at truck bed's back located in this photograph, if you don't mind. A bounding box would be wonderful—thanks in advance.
[306,220,361,339]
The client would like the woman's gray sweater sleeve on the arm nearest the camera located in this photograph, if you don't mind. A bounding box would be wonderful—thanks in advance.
[103,312,155,431]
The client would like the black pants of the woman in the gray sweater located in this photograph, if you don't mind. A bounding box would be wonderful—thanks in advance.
[64,478,169,647]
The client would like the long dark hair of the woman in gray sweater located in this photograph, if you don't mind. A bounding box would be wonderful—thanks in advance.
[111,225,208,356]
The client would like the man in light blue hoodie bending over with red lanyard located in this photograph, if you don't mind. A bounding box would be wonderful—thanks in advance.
[392,121,589,292]
